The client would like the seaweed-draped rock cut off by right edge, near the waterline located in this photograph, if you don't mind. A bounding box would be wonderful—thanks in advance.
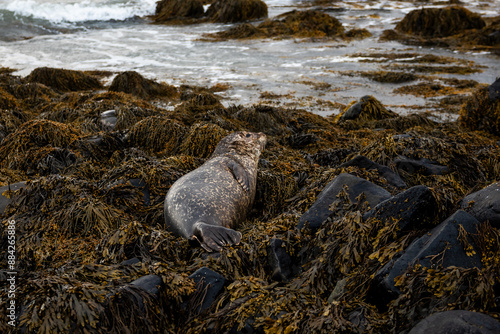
[458,80,500,136]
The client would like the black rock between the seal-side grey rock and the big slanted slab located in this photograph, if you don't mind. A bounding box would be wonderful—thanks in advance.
[363,186,438,235]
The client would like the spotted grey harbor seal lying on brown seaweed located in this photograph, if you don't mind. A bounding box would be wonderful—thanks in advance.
[164,131,266,252]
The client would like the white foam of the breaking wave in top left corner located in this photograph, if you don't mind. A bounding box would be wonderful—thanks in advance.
[0,0,157,23]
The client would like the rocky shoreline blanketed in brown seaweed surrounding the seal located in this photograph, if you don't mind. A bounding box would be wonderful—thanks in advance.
[0,1,500,334]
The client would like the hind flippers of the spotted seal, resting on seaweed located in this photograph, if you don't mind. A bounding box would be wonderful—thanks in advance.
[192,222,241,252]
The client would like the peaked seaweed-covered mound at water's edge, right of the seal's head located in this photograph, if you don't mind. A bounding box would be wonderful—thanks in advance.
[336,95,397,122]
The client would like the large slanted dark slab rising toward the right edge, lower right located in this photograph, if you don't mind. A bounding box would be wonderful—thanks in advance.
[371,210,482,301]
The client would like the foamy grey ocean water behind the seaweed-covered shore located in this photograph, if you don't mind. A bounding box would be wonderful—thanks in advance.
[0,0,500,118]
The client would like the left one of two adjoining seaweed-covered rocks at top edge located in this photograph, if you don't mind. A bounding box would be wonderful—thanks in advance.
[153,0,205,23]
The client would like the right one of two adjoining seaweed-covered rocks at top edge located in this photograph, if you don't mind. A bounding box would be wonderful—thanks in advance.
[206,0,267,23]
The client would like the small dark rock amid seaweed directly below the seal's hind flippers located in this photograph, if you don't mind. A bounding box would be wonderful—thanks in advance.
[189,267,226,313]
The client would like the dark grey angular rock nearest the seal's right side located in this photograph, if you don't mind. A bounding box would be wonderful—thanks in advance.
[298,173,391,230]
